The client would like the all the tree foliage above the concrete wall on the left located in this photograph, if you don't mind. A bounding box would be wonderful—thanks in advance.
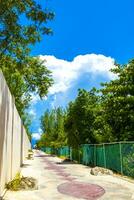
[0,0,54,136]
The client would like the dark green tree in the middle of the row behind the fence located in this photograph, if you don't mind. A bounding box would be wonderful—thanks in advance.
[65,89,98,147]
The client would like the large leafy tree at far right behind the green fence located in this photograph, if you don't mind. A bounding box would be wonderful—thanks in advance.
[101,60,134,141]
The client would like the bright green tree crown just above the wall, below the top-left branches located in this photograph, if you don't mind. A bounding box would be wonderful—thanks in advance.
[0,56,53,116]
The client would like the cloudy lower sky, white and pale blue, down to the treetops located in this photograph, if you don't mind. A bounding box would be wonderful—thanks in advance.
[29,54,114,138]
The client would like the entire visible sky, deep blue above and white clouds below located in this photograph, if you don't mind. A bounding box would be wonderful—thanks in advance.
[29,0,134,139]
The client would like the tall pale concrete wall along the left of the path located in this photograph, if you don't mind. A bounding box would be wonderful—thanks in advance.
[0,72,31,196]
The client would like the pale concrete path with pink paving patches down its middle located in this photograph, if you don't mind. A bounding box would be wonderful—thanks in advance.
[4,151,134,200]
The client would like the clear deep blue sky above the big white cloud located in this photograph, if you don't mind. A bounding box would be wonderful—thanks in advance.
[32,0,134,63]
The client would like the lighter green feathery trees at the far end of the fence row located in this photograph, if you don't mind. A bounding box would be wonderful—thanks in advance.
[37,107,66,148]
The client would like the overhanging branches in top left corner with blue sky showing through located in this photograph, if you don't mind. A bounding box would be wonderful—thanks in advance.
[0,0,54,59]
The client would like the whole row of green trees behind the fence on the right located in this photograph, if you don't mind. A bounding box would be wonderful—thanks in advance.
[38,60,134,147]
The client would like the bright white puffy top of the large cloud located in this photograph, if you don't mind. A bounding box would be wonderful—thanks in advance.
[39,54,114,94]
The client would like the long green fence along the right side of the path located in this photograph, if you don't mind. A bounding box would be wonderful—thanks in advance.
[44,142,134,178]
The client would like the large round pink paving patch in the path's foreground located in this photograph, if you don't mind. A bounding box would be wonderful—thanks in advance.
[57,181,105,200]
